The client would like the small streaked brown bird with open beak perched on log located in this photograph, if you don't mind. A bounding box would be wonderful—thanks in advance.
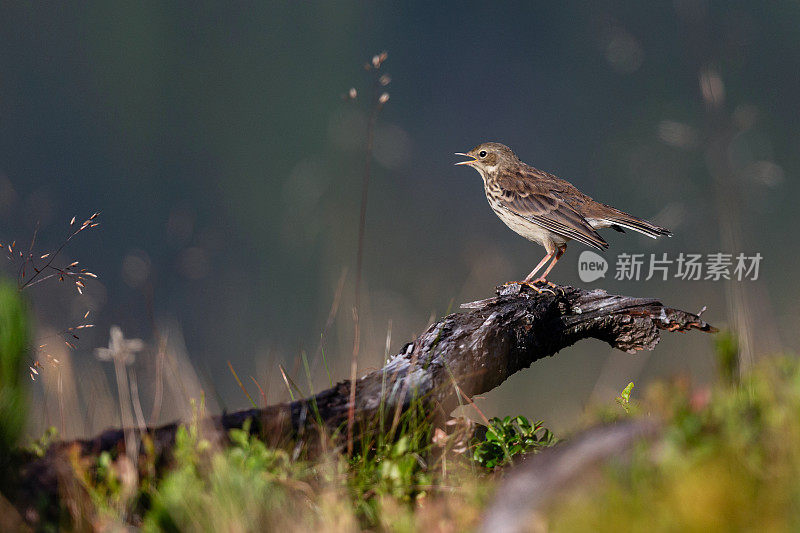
[456,143,672,285]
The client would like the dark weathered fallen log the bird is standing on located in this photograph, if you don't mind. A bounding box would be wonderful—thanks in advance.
[18,283,715,498]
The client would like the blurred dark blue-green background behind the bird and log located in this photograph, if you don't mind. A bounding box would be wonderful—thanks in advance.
[0,0,800,434]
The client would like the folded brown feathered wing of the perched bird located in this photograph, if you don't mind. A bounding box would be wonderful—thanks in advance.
[500,172,608,250]
